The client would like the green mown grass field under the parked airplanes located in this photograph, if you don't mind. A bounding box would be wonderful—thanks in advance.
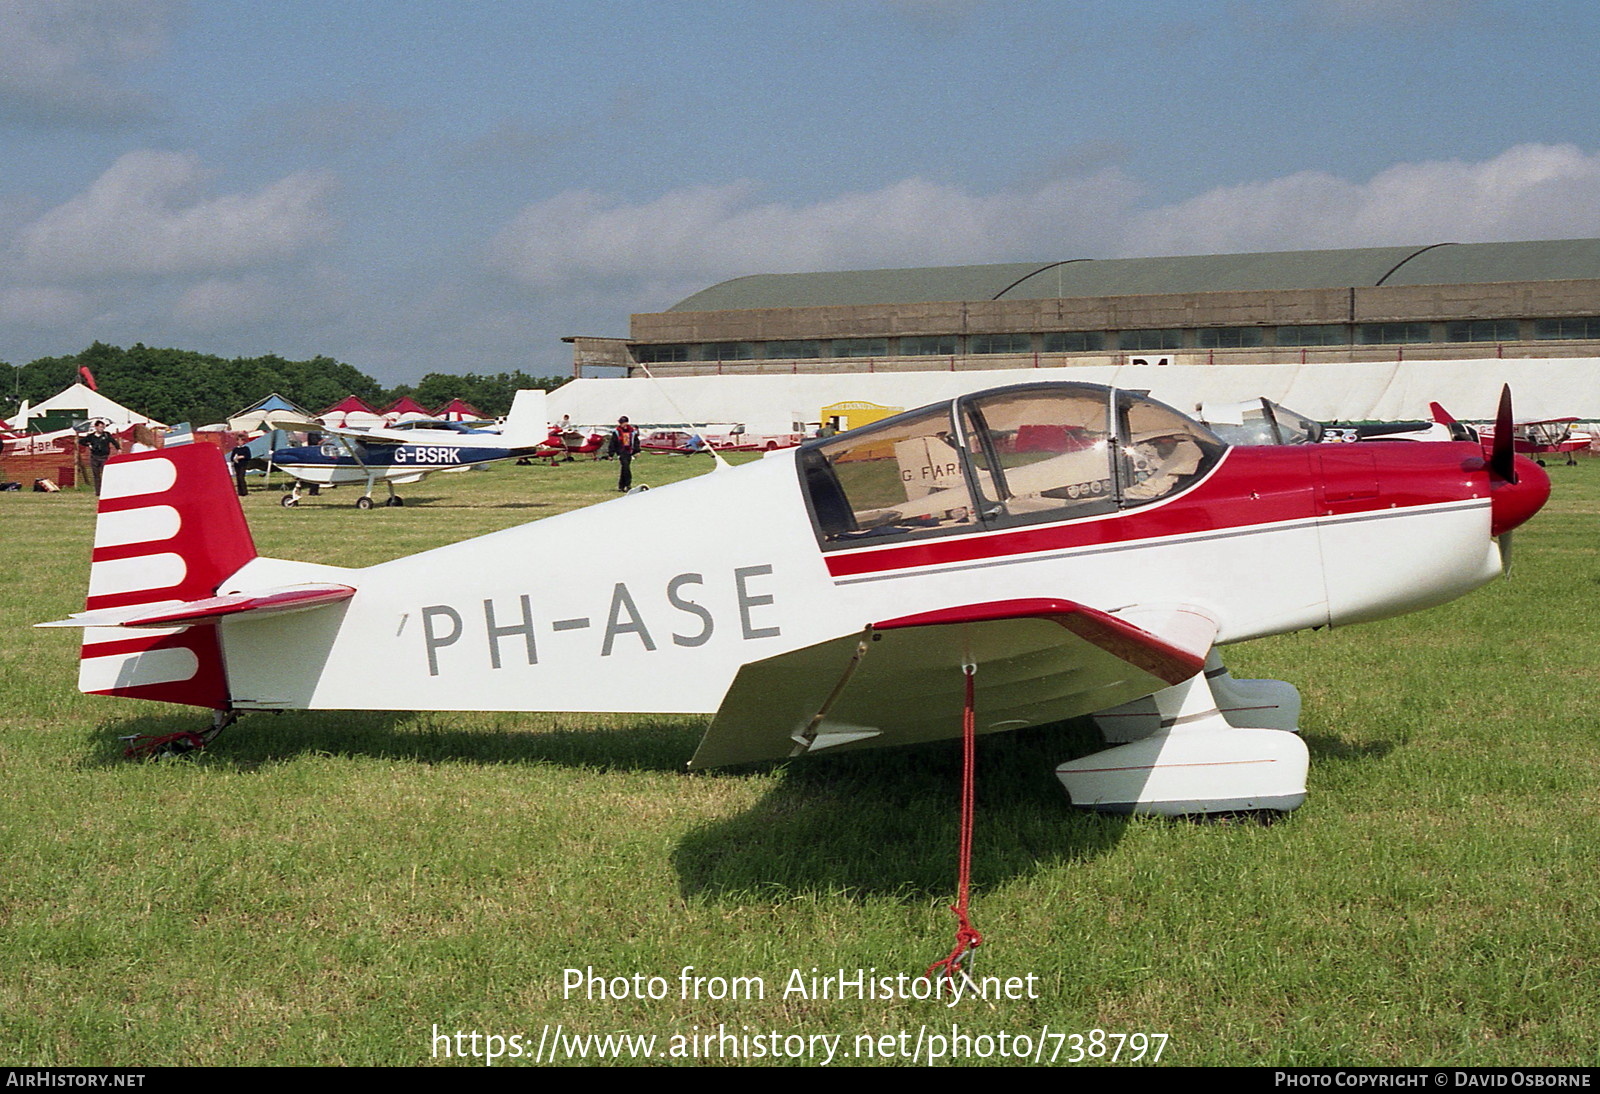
[0,447,1600,1065]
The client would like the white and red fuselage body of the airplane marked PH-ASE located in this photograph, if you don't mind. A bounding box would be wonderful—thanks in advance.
[222,445,1501,713]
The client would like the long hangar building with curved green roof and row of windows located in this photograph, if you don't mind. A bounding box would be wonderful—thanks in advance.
[566,240,1600,376]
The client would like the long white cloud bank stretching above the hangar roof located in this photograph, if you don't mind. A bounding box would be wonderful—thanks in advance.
[490,144,1600,311]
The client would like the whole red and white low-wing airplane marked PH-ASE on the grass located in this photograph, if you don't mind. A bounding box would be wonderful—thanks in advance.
[46,382,1549,814]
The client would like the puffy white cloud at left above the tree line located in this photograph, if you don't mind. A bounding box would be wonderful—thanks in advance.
[18,150,334,278]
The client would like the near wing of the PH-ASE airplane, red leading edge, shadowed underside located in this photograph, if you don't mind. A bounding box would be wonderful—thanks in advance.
[690,600,1218,768]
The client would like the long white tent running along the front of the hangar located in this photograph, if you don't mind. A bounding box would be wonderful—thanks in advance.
[550,357,1600,429]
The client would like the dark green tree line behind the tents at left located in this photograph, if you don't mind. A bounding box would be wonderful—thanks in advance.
[0,342,566,425]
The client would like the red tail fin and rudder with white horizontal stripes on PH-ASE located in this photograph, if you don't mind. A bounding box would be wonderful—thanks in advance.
[78,445,256,710]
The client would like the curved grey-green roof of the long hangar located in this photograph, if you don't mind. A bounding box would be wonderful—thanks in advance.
[669,240,1600,312]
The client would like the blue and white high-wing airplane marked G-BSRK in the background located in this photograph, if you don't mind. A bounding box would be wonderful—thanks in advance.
[270,390,546,509]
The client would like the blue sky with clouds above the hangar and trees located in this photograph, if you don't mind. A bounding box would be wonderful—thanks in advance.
[0,0,1600,384]
